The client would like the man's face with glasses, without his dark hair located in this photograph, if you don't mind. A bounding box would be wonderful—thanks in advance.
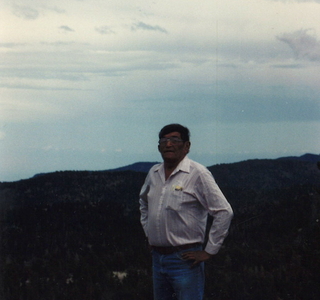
[158,132,190,163]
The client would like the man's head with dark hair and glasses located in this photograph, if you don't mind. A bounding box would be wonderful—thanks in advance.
[158,124,190,165]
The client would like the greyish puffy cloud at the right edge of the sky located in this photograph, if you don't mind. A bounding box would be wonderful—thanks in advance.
[277,29,320,61]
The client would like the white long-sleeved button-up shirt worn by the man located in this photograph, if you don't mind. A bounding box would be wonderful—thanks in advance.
[139,157,233,254]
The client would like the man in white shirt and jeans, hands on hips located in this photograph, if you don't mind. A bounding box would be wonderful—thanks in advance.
[139,124,233,300]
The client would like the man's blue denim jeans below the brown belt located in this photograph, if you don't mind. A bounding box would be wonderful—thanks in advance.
[152,246,204,300]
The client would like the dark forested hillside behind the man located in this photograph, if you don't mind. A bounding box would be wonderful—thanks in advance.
[0,159,320,300]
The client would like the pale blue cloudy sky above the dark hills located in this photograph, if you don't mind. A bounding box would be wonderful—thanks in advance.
[0,0,320,181]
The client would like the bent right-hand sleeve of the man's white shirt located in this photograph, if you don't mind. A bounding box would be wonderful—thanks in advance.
[197,170,233,255]
